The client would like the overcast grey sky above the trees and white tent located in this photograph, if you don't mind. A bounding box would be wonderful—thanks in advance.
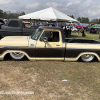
[0,0,100,19]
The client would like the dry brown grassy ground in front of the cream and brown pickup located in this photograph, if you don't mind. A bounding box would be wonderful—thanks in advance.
[0,61,100,100]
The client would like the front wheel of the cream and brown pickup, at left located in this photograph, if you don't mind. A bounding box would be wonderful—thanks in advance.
[9,52,25,61]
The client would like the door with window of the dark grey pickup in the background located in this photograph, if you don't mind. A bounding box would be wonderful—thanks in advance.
[7,20,22,36]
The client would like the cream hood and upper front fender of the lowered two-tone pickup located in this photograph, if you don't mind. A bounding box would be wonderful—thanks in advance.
[0,36,28,46]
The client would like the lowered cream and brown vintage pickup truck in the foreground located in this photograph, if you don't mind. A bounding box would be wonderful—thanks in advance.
[0,26,100,62]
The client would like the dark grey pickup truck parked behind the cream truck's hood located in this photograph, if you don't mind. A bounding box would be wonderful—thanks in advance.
[0,19,36,38]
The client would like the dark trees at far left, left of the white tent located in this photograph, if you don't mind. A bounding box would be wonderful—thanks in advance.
[0,9,25,19]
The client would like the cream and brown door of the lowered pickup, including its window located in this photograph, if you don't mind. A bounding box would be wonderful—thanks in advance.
[36,30,65,60]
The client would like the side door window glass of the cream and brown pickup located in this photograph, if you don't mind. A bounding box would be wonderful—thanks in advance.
[40,31,59,42]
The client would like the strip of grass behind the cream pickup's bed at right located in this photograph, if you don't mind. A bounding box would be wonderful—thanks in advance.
[69,32,100,41]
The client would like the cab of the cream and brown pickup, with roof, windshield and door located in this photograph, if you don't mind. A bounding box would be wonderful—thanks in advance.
[29,26,65,60]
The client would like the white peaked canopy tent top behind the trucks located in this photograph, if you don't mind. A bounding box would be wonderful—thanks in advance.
[18,7,79,22]
